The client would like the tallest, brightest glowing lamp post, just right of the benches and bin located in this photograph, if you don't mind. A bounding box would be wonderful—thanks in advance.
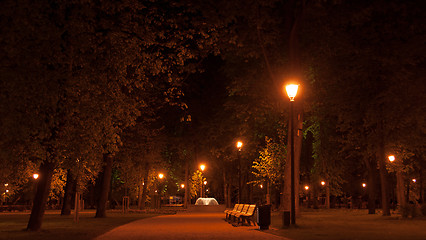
[285,84,299,225]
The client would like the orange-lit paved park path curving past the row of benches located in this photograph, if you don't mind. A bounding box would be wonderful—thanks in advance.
[96,212,288,240]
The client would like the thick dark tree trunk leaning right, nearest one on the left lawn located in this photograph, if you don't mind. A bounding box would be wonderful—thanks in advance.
[27,161,55,231]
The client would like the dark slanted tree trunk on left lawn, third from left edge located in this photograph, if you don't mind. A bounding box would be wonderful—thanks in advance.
[95,154,113,218]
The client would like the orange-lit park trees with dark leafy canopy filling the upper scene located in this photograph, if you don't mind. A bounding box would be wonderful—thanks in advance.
[0,0,425,230]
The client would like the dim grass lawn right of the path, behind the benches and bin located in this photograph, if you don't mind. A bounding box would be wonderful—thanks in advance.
[268,209,426,240]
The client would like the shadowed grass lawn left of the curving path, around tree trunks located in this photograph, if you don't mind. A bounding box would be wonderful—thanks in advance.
[0,211,158,240]
